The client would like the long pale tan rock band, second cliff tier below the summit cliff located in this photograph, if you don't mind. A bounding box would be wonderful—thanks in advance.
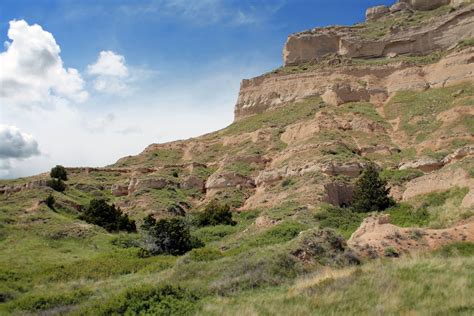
[235,48,474,120]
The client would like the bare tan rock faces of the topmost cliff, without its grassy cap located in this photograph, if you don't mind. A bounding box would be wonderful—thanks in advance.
[283,0,474,66]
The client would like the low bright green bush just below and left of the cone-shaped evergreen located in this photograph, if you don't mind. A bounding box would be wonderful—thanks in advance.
[315,206,365,239]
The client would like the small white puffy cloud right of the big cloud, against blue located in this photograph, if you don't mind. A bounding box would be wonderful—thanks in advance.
[87,51,130,94]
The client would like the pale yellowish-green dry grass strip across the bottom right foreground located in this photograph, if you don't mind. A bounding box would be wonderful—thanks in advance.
[198,257,474,315]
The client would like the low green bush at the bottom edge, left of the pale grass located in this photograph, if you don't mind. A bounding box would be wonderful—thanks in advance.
[85,285,199,315]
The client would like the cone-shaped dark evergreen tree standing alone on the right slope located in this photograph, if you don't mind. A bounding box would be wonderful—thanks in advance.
[352,164,395,212]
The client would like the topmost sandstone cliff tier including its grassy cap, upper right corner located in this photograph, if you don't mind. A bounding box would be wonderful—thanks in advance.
[283,0,474,66]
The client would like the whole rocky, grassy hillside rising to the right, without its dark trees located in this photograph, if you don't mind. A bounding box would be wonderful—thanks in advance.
[0,0,474,315]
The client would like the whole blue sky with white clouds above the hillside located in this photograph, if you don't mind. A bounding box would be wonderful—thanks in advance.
[0,0,394,178]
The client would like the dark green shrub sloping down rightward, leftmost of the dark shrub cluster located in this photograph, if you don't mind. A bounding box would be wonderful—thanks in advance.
[80,199,137,232]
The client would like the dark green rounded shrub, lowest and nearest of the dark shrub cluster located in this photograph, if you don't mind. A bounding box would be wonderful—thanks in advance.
[141,216,204,255]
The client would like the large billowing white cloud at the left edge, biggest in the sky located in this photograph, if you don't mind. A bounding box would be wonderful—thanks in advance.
[0,20,88,105]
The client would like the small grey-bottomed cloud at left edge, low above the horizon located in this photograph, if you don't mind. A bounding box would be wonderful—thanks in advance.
[0,125,40,176]
